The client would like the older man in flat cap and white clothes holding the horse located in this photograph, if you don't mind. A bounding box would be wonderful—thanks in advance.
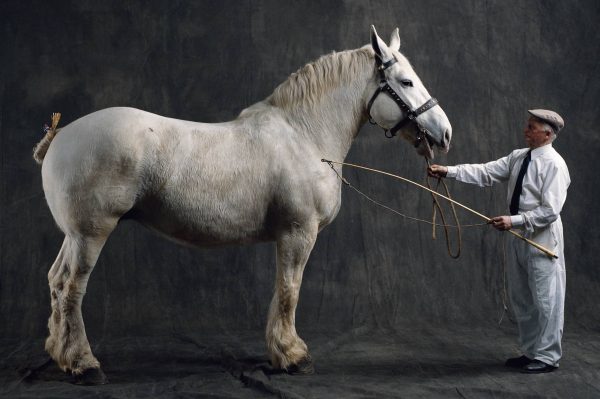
[428,109,571,373]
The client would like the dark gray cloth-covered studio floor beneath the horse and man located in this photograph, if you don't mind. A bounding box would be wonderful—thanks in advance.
[0,323,600,398]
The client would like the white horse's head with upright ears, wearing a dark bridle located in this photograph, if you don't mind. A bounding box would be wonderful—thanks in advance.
[366,26,452,159]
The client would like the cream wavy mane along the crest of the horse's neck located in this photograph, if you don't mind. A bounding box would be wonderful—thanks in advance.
[268,46,374,109]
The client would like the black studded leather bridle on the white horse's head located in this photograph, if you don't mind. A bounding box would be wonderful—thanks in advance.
[367,55,438,147]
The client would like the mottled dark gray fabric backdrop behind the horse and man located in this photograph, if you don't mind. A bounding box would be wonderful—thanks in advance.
[0,0,600,342]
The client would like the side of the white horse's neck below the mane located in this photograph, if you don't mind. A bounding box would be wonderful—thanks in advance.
[287,80,367,160]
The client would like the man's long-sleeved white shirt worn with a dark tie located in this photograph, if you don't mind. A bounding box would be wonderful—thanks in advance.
[447,144,571,231]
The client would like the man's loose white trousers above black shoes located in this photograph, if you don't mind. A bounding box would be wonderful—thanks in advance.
[507,218,566,367]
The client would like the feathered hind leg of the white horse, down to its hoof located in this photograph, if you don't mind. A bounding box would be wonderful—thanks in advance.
[46,226,114,384]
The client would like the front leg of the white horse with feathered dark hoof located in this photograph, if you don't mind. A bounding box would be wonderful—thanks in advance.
[266,223,318,373]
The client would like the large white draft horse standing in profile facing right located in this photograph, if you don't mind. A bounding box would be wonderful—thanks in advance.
[34,27,451,384]
